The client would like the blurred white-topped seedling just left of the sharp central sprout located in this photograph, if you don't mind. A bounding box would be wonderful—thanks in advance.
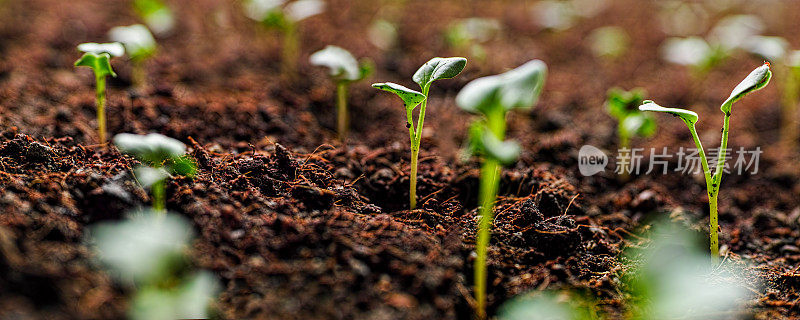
[309,46,374,143]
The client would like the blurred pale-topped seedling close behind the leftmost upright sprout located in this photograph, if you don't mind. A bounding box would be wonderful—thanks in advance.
[108,24,156,89]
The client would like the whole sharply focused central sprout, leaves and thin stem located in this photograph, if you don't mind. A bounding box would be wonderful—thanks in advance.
[372,57,467,210]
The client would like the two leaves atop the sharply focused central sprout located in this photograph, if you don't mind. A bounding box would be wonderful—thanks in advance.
[372,57,467,110]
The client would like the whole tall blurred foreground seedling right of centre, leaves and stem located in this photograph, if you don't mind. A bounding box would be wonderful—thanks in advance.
[456,60,547,319]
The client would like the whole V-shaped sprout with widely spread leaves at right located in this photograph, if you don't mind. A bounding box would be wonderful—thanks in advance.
[639,62,772,260]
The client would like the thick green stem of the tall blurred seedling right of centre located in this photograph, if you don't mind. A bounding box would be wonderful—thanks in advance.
[475,106,506,319]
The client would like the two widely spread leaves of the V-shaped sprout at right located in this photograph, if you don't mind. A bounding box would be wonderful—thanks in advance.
[639,62,772,126]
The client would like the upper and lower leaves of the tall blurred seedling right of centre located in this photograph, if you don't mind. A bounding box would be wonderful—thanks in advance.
[456,60,547,165]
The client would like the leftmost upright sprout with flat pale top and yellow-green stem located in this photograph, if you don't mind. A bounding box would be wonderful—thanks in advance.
[75,42,125,144]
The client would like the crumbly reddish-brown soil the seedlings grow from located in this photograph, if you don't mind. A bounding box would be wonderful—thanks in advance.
[0,0,800,319]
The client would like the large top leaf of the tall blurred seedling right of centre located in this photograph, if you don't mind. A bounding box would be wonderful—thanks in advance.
[456,60,547,114]
